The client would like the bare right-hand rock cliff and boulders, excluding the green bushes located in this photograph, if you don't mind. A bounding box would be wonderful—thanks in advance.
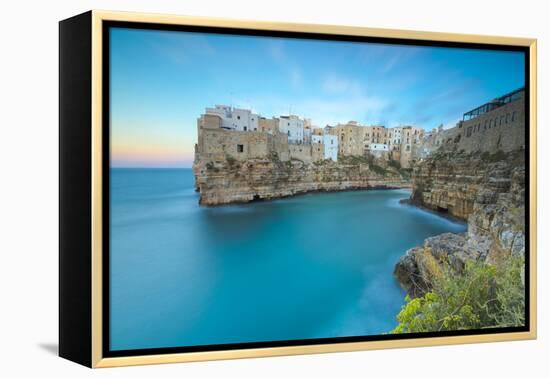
[394,150,526,297]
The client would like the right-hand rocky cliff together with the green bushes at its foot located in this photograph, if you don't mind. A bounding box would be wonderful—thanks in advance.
[392,146,526,333]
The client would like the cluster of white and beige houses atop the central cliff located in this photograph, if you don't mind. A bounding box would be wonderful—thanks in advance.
[198,105,424,167]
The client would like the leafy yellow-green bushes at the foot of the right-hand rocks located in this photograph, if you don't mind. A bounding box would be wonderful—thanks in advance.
[392,253,525,334]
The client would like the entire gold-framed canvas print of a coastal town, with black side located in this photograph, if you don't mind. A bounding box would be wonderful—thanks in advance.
[59,11,536,367]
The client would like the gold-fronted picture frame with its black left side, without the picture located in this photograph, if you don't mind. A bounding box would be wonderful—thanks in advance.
[60,10,537,368]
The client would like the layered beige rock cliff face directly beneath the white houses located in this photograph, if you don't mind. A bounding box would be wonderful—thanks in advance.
[193,157,410,205]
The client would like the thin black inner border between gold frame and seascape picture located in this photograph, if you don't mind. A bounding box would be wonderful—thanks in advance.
[101,21,531,358]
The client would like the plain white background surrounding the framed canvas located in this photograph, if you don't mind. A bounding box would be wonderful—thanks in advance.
[0,0,550,378]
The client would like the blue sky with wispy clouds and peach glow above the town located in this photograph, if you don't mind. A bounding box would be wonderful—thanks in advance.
[110,28,524,167]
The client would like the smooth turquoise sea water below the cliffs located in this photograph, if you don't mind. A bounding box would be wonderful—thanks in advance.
[110,169,465,350]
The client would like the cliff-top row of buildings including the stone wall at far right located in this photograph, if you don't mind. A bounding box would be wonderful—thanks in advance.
[196,88,525,168]
